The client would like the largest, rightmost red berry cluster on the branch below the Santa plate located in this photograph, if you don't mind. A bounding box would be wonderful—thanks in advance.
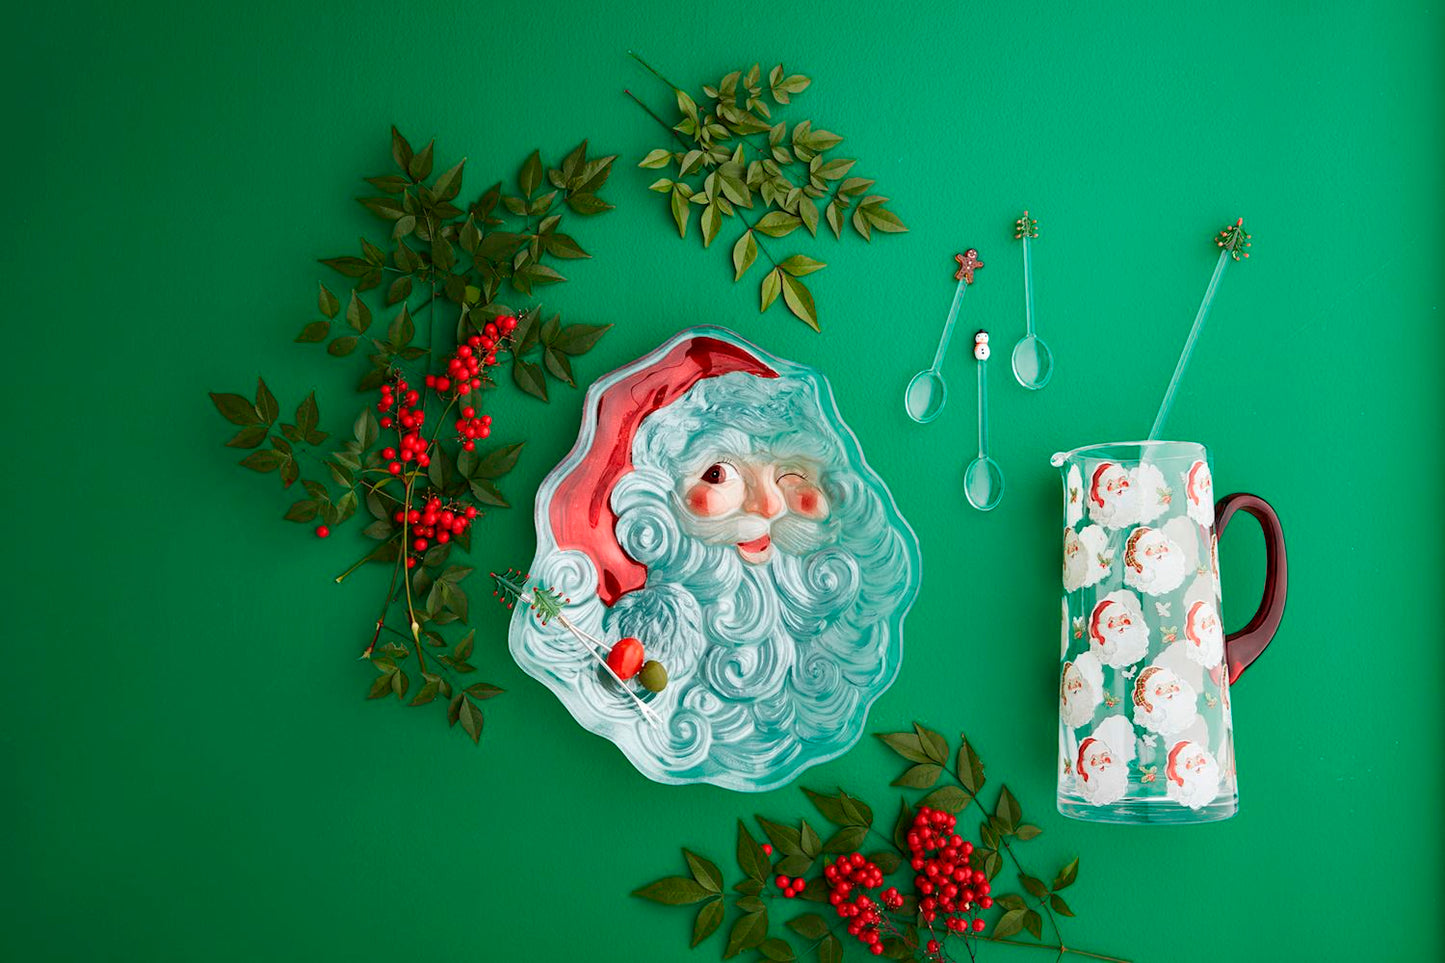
[907,805,993,953]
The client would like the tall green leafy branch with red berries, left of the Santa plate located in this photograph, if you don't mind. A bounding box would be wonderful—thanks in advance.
[211,127,614,740]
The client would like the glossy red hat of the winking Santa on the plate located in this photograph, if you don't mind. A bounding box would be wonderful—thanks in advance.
[551,335,777,607]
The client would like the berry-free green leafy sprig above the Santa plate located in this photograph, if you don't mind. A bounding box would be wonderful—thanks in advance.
[626,54,907,331]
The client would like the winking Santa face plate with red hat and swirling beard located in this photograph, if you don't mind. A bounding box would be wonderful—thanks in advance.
[510,327,919,791]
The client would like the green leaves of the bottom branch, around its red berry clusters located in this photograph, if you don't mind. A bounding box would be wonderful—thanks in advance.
[633,723,1124,963]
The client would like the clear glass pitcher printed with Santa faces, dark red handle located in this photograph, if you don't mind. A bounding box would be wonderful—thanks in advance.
[1052,441,1287,823]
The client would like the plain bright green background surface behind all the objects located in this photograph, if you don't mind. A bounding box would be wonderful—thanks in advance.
[11,1,1445,962]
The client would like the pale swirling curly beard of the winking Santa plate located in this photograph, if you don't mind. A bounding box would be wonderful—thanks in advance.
[604,468,909,772]
